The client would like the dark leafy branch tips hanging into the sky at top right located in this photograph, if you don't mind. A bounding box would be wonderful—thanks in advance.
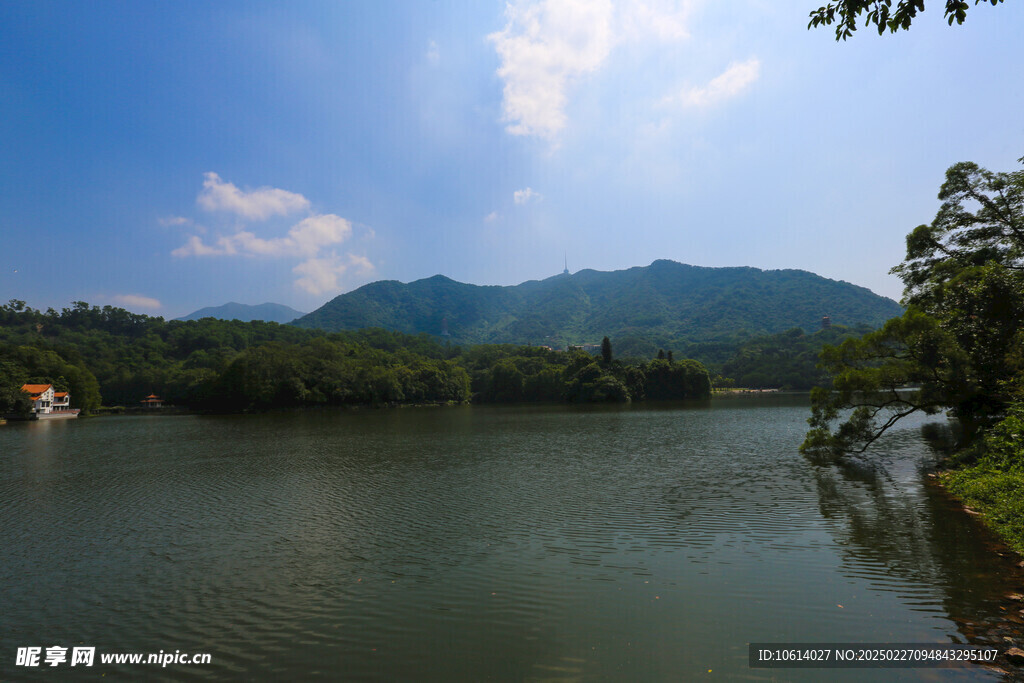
[807,0,1002,40]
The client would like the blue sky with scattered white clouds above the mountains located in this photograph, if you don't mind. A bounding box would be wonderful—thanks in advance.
[0,0,1024,317]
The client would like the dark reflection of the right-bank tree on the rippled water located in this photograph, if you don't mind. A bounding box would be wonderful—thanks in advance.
[815,423,1024,675]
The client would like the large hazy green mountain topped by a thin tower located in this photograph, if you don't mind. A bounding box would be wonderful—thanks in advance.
[294,260,902,346]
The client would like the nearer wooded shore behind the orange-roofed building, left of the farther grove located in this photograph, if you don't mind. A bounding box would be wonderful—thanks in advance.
[0,301,460,411]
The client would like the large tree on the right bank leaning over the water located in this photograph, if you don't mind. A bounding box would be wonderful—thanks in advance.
[801,163,1024,455]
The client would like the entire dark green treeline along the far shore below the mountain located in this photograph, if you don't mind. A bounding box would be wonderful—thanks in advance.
[0,301,710,412]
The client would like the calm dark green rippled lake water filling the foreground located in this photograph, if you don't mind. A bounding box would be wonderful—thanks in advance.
[0,395,1021,681]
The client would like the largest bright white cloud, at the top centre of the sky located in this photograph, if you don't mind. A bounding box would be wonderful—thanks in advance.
[487,0,697,139]
